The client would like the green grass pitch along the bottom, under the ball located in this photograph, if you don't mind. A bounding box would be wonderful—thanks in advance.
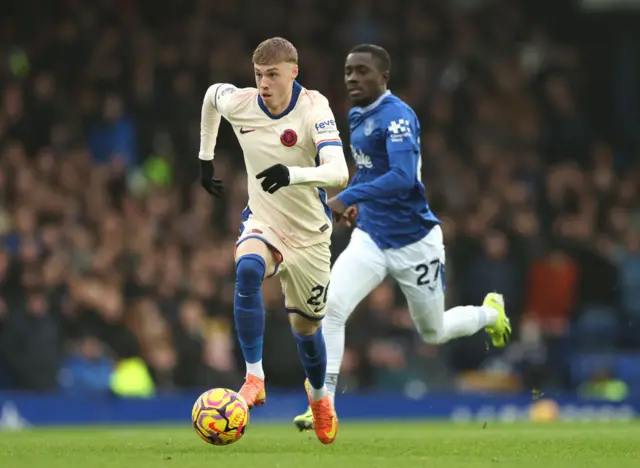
[0,422,640,468]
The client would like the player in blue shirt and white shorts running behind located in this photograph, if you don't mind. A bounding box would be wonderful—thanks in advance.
[294,44,511,430]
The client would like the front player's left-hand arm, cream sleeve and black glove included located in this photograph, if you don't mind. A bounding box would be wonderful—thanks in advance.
[198,83,237,196]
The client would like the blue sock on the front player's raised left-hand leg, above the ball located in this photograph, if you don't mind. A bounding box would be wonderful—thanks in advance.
[233,254,266,363]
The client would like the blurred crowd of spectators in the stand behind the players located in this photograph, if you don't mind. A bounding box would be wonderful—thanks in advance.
[0,0,640,393]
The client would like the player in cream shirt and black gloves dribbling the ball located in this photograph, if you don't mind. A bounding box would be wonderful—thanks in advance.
[199,37,349,444]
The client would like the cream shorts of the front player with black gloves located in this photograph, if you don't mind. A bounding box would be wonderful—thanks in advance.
[236,218,331,321]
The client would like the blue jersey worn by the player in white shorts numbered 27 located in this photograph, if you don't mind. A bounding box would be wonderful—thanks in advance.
[338,91,440,249]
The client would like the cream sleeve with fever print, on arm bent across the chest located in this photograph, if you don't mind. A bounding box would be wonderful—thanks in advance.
[289,99,349,187]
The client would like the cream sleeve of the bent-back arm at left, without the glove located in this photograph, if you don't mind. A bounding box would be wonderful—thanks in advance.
[199,83,237,161]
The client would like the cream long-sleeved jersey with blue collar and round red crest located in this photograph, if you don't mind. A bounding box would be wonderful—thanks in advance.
[200,82,349,246]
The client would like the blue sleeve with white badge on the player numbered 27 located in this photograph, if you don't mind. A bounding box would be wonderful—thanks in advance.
[338,111,420,206]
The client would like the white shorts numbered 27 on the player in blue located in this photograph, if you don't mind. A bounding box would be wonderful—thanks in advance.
[327,225,445,333]
